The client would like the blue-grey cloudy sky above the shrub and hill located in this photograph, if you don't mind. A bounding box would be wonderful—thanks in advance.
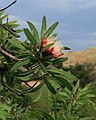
[0,0,96,51]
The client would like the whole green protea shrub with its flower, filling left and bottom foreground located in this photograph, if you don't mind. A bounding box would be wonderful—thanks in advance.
[0,11,95,120]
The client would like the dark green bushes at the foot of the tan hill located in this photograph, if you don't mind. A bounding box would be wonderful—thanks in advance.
[68,63,96,87]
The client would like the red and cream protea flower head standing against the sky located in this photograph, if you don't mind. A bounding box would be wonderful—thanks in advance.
[41,37,63,58]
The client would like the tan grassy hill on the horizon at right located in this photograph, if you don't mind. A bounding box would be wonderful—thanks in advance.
[64,47,96,66]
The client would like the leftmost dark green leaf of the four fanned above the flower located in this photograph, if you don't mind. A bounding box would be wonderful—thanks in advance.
[24,28,37,45]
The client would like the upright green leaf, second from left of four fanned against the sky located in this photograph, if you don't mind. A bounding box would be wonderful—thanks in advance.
[27,21,39,43]
